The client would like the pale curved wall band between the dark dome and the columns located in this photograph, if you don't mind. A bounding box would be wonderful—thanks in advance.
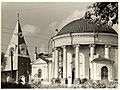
[53,33,118,47]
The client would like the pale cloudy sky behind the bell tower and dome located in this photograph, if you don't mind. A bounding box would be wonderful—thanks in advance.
[1,2,116,60]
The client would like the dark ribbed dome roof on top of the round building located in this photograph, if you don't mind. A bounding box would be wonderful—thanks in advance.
[57,19,117,36]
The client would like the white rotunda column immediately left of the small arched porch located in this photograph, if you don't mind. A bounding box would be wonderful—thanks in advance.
[89,44,95,79]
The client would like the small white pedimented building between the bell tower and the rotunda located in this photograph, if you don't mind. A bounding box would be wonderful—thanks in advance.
[31,52,52,82]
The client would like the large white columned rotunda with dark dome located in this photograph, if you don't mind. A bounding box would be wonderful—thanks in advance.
[51,19,118,84]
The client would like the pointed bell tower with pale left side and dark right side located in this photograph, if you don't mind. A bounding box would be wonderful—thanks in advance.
[1,15,31,83]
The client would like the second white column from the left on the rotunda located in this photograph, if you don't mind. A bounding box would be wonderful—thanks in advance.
[62,46,67,84]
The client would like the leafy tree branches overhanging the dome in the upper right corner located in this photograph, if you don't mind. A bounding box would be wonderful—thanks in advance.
[87,2,118,27]
